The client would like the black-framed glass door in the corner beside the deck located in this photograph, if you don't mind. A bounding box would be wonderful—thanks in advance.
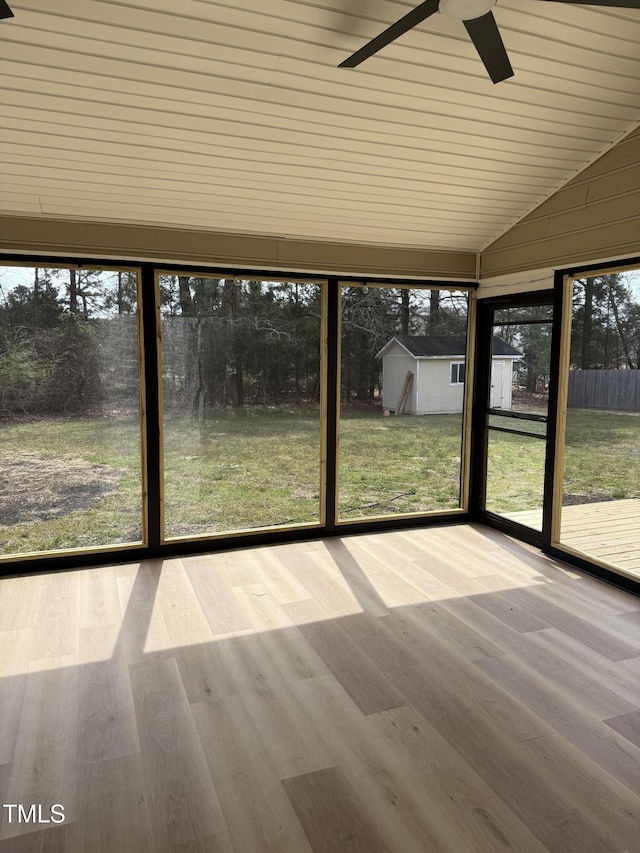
[476,293,553,539]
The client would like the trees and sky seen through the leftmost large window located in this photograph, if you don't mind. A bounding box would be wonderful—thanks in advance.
[0,267,139,417]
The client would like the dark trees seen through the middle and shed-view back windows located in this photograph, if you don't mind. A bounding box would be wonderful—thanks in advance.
[160,276,467,416]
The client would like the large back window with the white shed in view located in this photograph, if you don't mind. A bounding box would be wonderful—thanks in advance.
[338,285,468,521]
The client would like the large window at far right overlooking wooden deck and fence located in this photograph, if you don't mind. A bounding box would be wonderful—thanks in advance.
[556,269,640,578]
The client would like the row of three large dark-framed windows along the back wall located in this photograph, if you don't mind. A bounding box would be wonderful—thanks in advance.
[0,257,475,566]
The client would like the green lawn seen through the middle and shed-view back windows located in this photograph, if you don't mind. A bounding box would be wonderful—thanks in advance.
[164,412,460,536]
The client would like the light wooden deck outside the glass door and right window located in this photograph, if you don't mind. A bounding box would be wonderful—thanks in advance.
[505,498,640,577]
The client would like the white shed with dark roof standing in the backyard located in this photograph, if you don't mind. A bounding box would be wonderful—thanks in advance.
[377,335,522,415]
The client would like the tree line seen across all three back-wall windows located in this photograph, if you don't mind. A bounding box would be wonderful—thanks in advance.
[0,268,467,417]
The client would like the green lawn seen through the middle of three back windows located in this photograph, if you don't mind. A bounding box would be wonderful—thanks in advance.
[164,410,320,536]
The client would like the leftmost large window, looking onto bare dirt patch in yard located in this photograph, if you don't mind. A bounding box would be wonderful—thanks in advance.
[0,266,144,555]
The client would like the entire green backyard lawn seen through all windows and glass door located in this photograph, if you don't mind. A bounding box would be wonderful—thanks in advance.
[0,410,640,553]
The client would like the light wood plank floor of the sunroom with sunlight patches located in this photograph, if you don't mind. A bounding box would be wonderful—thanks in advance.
[0,526,640,853]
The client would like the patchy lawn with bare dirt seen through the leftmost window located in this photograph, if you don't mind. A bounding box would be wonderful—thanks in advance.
[0,419,142,554]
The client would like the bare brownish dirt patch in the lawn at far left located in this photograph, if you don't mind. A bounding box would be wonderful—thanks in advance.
[0,453,125,527]
